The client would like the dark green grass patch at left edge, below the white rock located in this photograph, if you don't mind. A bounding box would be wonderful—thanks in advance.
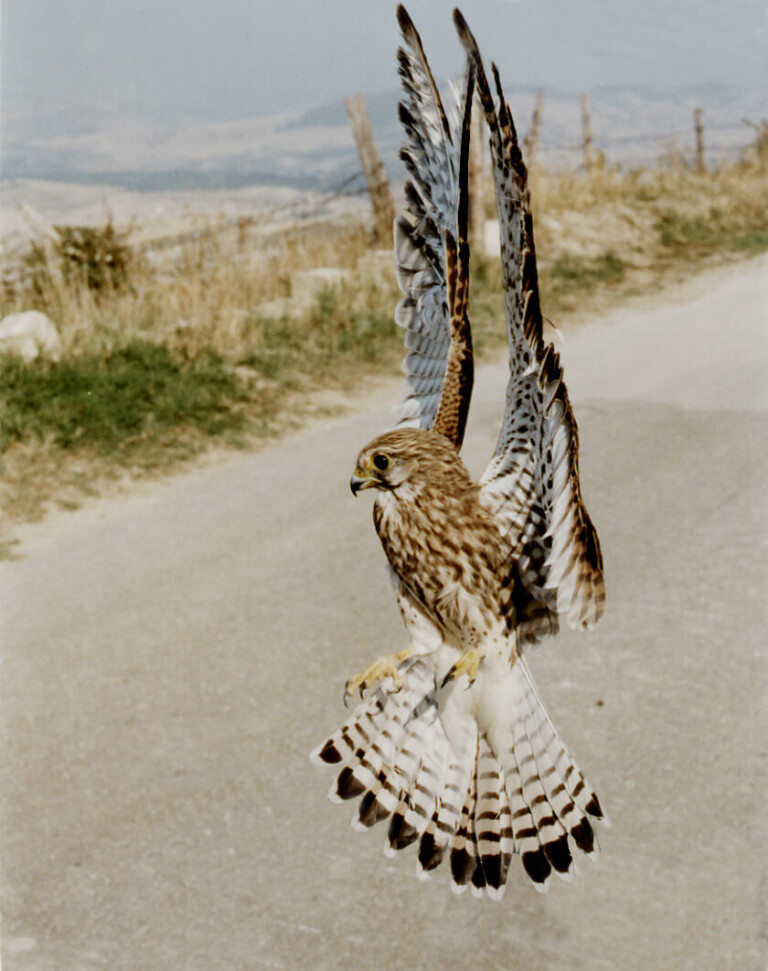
[0,340,246,454]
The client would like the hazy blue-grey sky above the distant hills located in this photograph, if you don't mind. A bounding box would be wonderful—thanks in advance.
[2,0,768,115]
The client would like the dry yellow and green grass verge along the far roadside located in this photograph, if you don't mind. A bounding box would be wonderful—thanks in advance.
[0,133,768,556]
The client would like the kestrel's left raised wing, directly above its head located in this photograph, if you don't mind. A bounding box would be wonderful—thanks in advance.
[395,6,474,449]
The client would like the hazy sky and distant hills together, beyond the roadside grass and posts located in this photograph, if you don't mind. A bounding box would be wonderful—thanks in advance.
[2,0,768,231]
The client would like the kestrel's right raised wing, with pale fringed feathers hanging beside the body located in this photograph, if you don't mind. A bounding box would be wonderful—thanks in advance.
[454,10,605,641]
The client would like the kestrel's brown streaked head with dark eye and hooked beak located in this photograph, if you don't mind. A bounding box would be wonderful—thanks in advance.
[349,428,463,495]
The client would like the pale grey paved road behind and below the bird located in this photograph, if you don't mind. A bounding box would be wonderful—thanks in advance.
[0,259,768,971]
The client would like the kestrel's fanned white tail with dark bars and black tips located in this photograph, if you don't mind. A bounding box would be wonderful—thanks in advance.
[312,657,603,900]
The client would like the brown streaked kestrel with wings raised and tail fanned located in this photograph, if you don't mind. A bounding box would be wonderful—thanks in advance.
[313,6,605,899]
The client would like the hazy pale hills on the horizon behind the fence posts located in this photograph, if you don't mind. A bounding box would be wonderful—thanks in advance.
[0,84,768,191]
